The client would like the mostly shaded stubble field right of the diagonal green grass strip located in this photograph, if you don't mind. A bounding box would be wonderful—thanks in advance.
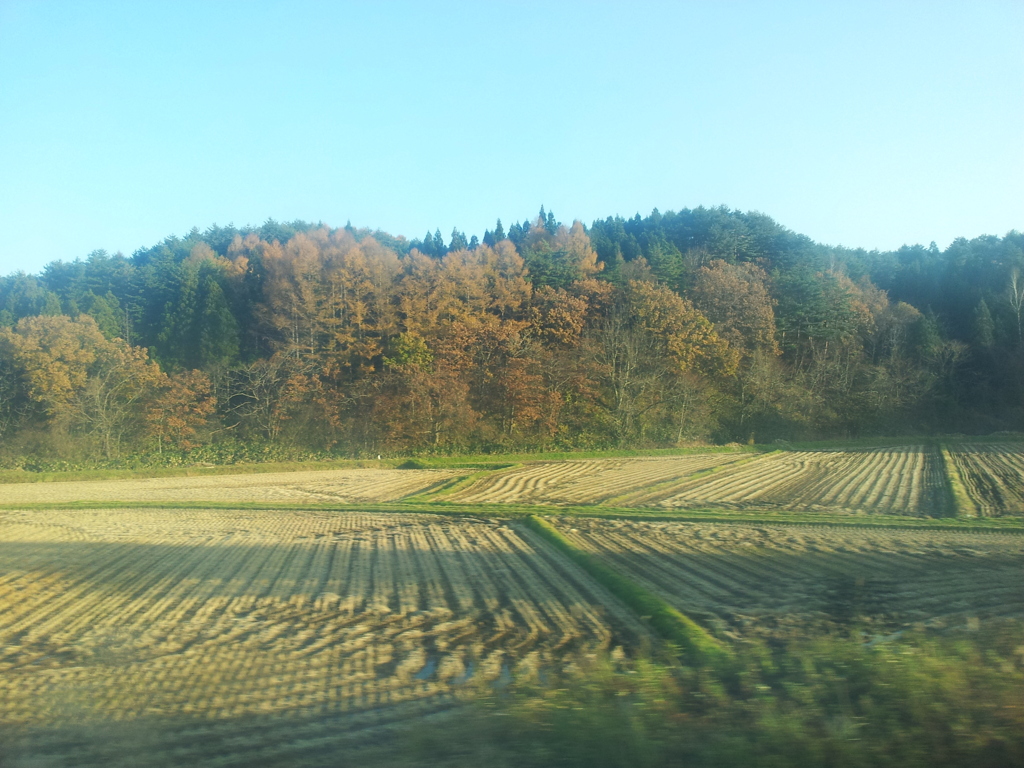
[558,517,1024,636]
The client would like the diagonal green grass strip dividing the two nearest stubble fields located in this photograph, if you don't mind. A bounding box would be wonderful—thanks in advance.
[524,515,729,666]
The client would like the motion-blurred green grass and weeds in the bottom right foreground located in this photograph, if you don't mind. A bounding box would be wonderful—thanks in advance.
[393,621,1024,768]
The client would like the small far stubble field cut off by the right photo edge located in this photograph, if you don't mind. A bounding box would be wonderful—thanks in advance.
[950,443,1024,517]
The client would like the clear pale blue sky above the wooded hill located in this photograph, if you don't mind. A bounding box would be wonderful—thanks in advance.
[0,0,1024,274]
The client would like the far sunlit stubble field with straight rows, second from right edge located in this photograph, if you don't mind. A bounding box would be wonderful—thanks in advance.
[645,446,949,517]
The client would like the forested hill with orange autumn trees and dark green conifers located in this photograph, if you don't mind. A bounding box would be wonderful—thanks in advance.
[0,208,1024,466]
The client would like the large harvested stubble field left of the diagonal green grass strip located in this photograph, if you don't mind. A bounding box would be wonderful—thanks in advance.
[0,507,643,766]
